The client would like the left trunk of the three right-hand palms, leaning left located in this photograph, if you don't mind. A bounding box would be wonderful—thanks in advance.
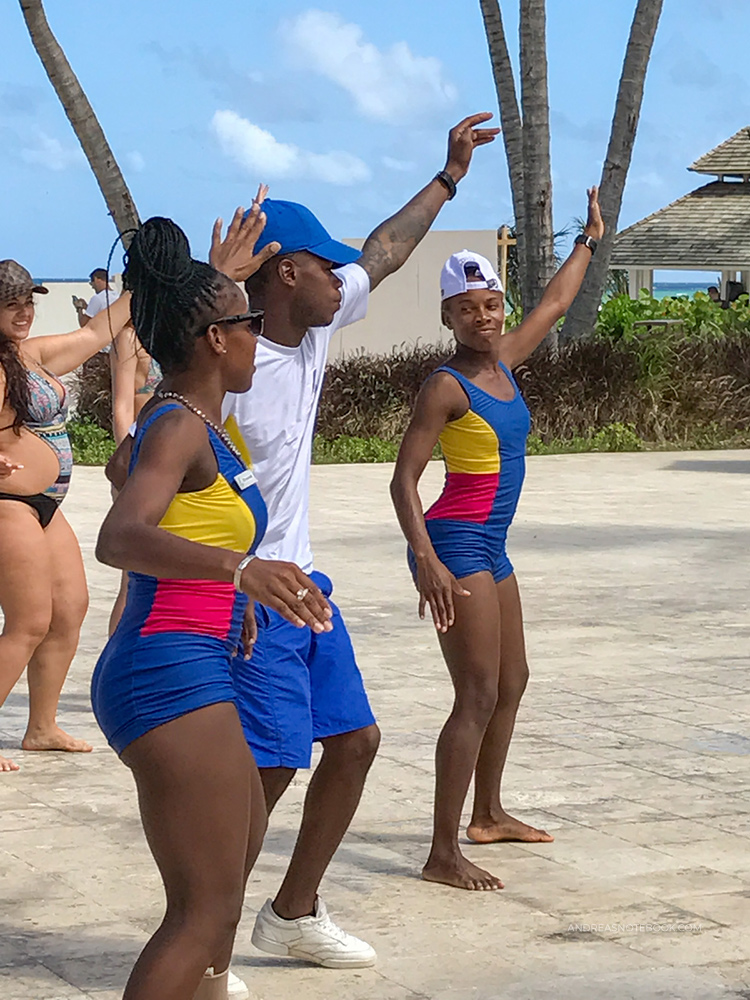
[480,0,525,304]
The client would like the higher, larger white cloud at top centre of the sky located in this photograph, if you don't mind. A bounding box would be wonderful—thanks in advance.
[282,10,457,123]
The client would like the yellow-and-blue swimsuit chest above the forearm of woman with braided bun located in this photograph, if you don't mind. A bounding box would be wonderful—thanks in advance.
[130,403,268,552]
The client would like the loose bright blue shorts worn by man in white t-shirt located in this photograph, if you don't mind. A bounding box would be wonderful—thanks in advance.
[232,572,375,768]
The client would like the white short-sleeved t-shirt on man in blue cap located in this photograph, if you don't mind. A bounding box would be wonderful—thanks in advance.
[223,264,370,573]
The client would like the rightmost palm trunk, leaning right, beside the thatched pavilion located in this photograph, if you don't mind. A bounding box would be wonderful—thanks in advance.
[562,0,663,339]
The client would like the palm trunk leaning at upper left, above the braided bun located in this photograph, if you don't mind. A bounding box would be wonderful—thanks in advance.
[20,0,140,233]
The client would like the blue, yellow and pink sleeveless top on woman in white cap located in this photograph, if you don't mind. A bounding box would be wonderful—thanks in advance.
[425,362,531,527]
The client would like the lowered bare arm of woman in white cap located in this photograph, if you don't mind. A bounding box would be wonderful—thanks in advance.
[391,372,468,632]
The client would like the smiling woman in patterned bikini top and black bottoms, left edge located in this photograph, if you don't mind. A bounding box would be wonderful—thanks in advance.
[0,260,129,771]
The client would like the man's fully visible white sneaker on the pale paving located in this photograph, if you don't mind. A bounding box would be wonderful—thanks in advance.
[252,896,377,969]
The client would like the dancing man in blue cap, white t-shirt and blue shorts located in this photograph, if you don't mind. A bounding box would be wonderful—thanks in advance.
[211,114,499,968]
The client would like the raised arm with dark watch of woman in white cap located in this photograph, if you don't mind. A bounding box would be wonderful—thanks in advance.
[500,187,604,368]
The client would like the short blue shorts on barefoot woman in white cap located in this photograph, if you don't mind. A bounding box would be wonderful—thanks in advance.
[406,518,513,583]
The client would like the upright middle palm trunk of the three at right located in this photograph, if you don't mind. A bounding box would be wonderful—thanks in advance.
[520,0,556,346]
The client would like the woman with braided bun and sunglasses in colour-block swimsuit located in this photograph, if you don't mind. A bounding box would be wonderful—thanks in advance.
[92,219,331,1000]
